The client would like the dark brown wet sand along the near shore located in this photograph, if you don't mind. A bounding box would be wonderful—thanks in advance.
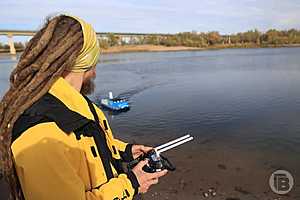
[129,135,300,200]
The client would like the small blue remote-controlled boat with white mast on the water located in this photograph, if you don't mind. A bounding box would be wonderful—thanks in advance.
[101,92,129,111]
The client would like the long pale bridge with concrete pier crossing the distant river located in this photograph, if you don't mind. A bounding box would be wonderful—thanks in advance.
[0,30,171,54]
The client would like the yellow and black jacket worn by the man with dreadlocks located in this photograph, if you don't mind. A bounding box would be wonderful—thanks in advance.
[11,78,139,200]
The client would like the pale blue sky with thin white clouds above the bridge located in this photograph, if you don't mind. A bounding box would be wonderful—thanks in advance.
[0,0,300,42]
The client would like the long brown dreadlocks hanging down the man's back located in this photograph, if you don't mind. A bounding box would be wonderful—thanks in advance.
[0,15,83,200]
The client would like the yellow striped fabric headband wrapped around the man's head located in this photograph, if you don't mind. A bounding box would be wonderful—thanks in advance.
[67,15,100,72]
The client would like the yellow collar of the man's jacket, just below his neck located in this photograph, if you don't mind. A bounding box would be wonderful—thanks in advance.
[48,77,94,120]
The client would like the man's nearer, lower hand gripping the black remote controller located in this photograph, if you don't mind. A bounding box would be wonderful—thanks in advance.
[132,160,168,193]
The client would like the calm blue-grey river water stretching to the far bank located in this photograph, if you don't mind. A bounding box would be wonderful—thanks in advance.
[0,48,300,198]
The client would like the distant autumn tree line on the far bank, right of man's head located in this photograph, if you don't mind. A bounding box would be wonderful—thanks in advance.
[99,29,300,48]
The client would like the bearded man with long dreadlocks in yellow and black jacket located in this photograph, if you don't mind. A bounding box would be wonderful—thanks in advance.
[0,15,166,200]
